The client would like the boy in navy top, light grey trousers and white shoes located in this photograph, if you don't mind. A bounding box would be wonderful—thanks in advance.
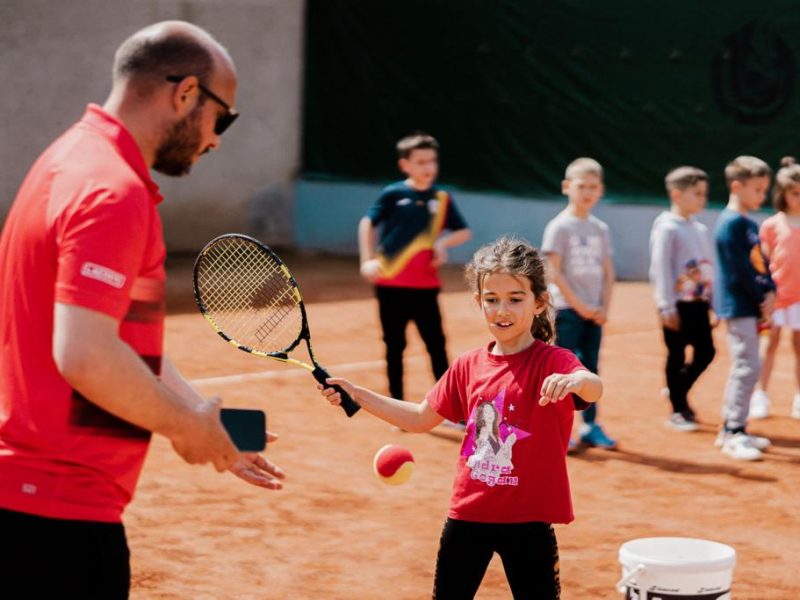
[714,156,775,460]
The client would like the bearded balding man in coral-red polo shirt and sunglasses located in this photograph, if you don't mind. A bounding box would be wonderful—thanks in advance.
[0,21,283,599]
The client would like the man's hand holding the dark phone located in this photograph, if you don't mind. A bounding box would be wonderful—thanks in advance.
[170,398,239,472]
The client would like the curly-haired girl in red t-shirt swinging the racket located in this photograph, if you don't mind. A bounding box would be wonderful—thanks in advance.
[322,237,603,600]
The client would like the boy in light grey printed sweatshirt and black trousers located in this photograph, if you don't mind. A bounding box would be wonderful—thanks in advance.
[650,167,715,431]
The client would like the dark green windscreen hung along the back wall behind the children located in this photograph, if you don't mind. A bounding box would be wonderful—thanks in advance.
[303,0,800,200]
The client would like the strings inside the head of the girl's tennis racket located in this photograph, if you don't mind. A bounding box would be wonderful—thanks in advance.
[197,238,303,352]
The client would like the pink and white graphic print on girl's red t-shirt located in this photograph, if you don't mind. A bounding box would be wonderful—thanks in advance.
[462,389,531,487]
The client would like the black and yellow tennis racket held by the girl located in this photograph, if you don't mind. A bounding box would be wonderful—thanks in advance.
[194,233,361,417]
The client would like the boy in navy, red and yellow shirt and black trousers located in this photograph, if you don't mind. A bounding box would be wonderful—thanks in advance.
[358,133,471,399]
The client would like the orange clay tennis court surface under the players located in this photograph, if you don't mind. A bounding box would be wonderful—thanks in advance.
[125,255,800,600]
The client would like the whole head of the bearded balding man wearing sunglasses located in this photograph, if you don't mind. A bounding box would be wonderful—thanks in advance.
[103,21,238,175]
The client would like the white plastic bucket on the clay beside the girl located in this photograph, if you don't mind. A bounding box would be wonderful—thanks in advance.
[617,537,736,600]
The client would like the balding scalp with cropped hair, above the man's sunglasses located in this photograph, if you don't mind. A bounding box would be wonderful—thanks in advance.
[113,21,235,94]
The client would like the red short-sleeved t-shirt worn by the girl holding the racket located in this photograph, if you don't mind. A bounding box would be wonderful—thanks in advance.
[426,340,585,523]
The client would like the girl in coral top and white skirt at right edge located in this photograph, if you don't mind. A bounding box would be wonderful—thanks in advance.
[750,156,800,419]
